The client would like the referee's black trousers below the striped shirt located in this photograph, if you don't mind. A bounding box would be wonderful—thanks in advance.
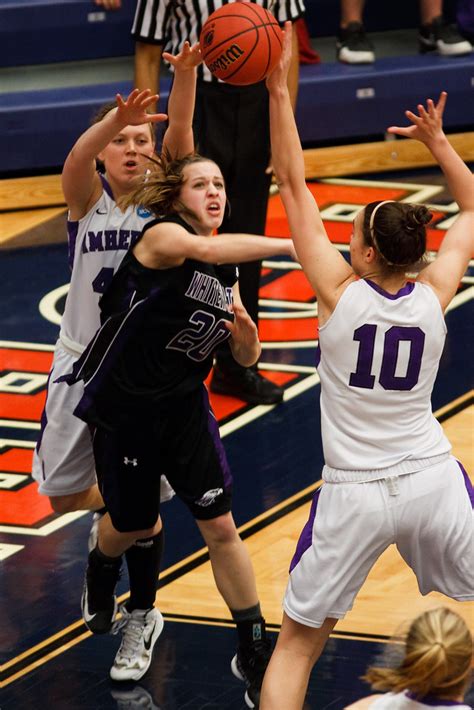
[194,81,271,371]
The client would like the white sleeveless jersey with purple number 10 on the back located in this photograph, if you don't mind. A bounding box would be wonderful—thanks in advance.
[318,279,451,480]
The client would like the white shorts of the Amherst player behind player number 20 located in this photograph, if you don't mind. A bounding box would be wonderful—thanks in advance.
[32,342,174,502]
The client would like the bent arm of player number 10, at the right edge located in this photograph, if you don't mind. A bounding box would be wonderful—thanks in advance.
[388,91,474,309]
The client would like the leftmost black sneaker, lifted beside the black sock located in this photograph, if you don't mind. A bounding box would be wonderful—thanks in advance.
[81,551,122,634]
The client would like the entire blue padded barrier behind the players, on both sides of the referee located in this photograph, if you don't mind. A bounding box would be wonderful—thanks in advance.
[0,55,474,174]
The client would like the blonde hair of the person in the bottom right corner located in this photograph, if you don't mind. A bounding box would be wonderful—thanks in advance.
[363,607,473,699]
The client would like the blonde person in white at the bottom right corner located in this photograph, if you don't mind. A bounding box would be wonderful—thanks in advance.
[346,607,472,710]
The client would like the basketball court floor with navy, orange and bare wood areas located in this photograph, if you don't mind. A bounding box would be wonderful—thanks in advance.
[0,161,474,710]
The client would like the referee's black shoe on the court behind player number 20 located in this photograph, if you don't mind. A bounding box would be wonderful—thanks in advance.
[211,367,284,404]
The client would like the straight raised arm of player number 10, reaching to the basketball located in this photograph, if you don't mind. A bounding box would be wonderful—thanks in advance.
[267,23,354,315]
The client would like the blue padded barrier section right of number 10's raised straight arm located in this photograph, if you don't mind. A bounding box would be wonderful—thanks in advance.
[296,54,474,144]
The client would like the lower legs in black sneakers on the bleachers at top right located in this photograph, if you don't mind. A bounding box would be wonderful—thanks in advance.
[336,0,473,64]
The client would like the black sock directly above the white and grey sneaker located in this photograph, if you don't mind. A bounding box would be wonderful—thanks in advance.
[125,530,164,611]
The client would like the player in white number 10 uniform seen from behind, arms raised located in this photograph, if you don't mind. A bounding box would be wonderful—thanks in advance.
[260,27,474,710]
